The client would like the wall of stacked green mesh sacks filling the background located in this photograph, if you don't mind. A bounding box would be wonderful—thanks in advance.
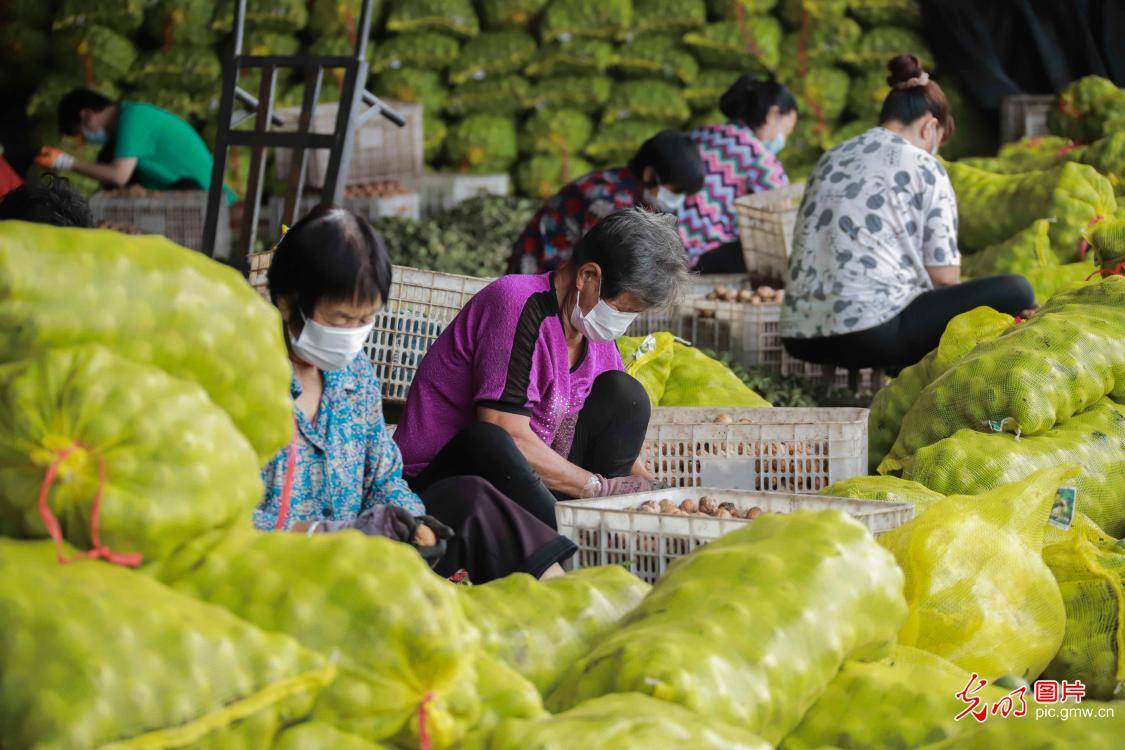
[8,0,989,198]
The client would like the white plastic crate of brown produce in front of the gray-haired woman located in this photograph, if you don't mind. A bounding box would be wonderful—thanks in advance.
[555,488,914,584]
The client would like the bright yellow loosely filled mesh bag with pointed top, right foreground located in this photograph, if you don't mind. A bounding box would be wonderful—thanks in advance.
[879,467,1079,679]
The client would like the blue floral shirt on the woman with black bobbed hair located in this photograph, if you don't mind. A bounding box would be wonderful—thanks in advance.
[254,354,425,531]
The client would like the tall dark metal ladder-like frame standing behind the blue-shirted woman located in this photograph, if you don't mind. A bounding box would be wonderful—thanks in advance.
[203,0,406,266]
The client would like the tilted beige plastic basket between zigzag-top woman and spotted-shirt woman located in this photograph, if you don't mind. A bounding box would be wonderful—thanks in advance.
[735,182,804,286]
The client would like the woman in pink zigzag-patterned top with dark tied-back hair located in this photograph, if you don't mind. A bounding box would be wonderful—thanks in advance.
[680,75,797,273]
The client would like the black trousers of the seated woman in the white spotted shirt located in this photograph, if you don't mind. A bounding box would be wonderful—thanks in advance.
[782,275,1035,374]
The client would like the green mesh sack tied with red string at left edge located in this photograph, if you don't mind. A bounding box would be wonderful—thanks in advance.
[0,346,262,566]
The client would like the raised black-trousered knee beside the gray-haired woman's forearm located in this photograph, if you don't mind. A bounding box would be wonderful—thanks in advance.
[568,370,653,477]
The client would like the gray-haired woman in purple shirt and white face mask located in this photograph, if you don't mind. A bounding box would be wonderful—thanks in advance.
[395,208,686,527]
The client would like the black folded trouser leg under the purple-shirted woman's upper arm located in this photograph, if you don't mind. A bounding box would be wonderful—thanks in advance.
[407,422,555,528]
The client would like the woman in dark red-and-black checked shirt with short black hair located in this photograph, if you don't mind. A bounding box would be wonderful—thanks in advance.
[507,130,703,273]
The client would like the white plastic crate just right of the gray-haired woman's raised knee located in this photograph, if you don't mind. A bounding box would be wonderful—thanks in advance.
[640,407,867,493]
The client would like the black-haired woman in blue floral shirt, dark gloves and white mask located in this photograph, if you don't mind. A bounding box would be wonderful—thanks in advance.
[254,207,575,582]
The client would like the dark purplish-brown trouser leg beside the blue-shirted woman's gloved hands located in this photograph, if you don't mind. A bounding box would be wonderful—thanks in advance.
[422,477,577,584]
